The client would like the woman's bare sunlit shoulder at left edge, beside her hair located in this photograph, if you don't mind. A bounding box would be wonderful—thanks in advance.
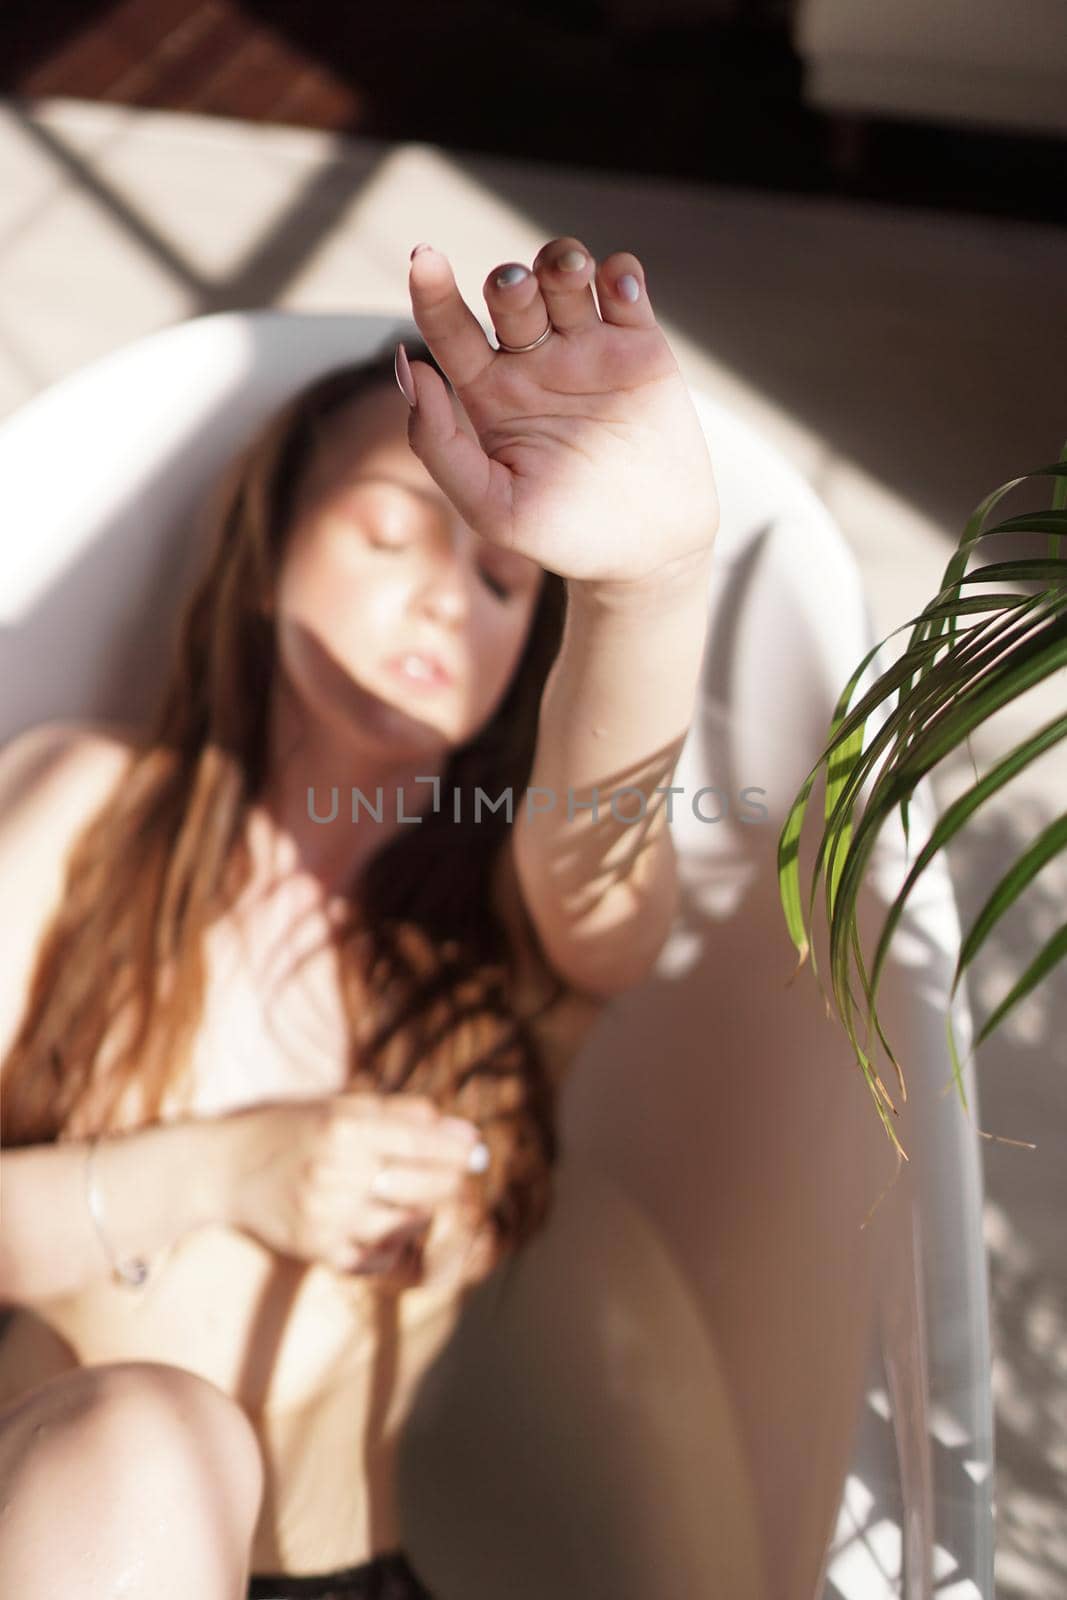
[0,722,138,1061]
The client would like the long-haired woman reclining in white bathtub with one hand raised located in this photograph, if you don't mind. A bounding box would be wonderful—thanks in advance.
[0,238,718,1600]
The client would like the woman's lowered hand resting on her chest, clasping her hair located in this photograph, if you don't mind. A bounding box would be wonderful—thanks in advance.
[220,1091,483,1282]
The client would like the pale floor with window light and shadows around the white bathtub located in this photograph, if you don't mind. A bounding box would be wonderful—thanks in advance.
[0,99,1067,1600]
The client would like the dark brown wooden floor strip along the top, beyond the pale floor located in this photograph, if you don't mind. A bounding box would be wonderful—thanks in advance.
[0,0,1067,222]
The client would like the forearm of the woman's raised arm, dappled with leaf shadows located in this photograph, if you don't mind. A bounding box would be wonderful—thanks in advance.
[515,555,710,989]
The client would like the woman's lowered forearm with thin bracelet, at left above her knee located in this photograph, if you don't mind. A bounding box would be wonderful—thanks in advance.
[0,1118,230,1304]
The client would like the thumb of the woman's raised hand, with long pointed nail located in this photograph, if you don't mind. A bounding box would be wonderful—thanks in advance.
[408,355,512,534]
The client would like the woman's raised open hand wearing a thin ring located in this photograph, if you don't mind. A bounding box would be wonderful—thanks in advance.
[397,238,718,584]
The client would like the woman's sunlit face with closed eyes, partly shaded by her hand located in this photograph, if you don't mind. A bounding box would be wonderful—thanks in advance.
[274,384,544,757]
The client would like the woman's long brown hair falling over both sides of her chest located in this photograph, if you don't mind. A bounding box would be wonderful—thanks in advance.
[0,338,565,1248]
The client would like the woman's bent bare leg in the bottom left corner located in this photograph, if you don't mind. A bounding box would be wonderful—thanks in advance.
[0,1362,262,1600]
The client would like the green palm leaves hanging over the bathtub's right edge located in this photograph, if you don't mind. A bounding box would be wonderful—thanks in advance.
[777,443,1067,1170]
